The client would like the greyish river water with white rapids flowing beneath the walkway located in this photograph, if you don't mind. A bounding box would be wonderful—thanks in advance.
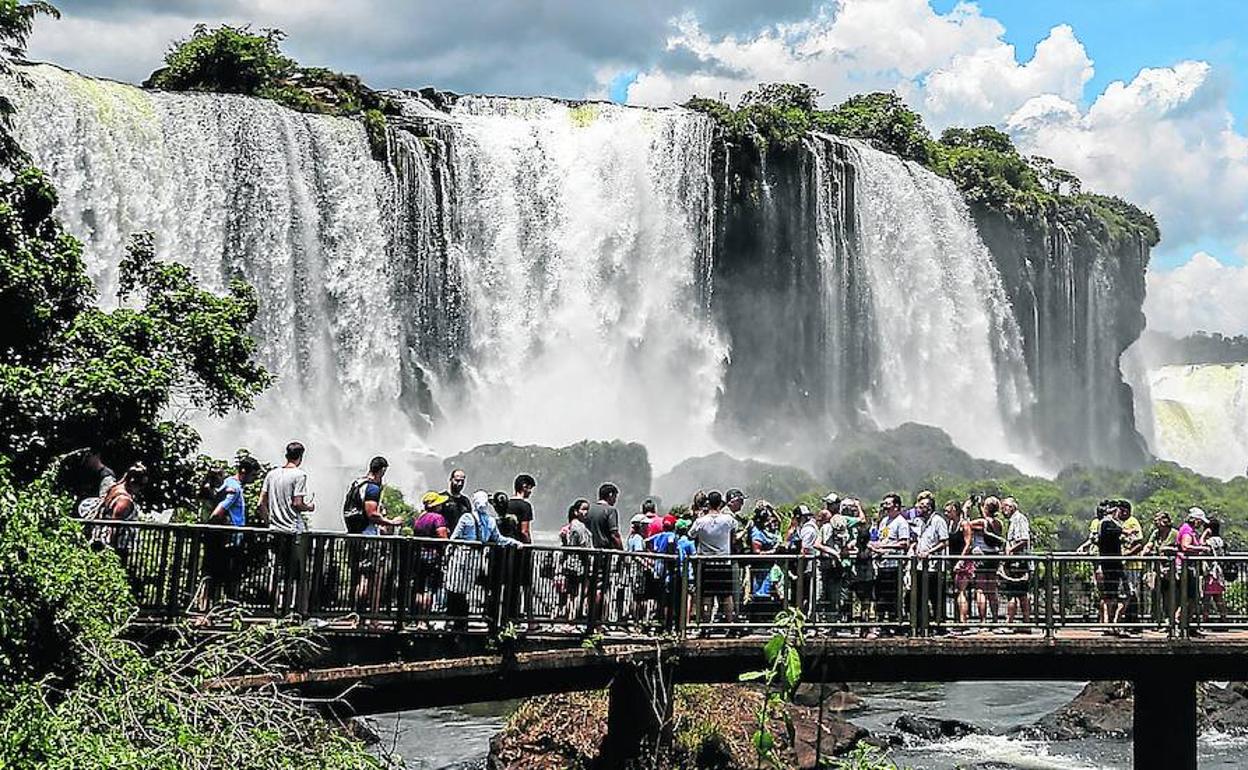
[378,681,1248,770]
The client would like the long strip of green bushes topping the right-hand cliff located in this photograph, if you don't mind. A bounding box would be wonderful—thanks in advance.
[685,84,1161,245]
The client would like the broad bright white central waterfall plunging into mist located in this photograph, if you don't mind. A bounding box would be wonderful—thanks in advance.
[433,97,726,465]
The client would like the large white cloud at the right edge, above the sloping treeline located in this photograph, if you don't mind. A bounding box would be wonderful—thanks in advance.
[1006,61,1248,248]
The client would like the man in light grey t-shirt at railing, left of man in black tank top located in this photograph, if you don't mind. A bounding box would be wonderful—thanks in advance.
[260,441,316,604]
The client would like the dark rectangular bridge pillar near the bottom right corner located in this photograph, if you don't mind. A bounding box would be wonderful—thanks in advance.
[1133,671,1196,770]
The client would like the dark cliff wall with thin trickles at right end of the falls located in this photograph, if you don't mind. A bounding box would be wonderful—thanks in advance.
[972,207,1151,468]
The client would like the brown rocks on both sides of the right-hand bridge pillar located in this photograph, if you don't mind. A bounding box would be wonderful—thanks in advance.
[1023,681,1248,740]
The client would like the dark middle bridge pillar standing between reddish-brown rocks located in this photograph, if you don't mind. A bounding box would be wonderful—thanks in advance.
[597,656,675,770]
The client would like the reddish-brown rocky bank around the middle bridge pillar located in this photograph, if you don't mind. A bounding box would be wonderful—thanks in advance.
[488,685,870,770]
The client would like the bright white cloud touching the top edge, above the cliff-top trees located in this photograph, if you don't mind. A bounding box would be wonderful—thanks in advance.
[619,0,1092,129]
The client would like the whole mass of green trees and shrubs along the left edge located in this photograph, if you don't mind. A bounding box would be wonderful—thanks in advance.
[0,0,386,770]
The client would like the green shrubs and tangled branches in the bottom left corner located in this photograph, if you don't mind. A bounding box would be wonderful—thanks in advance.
[0,468,382,770]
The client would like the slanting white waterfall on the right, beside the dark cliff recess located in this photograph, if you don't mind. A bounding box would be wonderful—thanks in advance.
[817,135,1038,469]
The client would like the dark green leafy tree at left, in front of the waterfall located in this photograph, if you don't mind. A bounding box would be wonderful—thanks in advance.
[0,184,270,507]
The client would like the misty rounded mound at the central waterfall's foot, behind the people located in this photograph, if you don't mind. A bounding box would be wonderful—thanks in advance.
[443,441,650,530]
